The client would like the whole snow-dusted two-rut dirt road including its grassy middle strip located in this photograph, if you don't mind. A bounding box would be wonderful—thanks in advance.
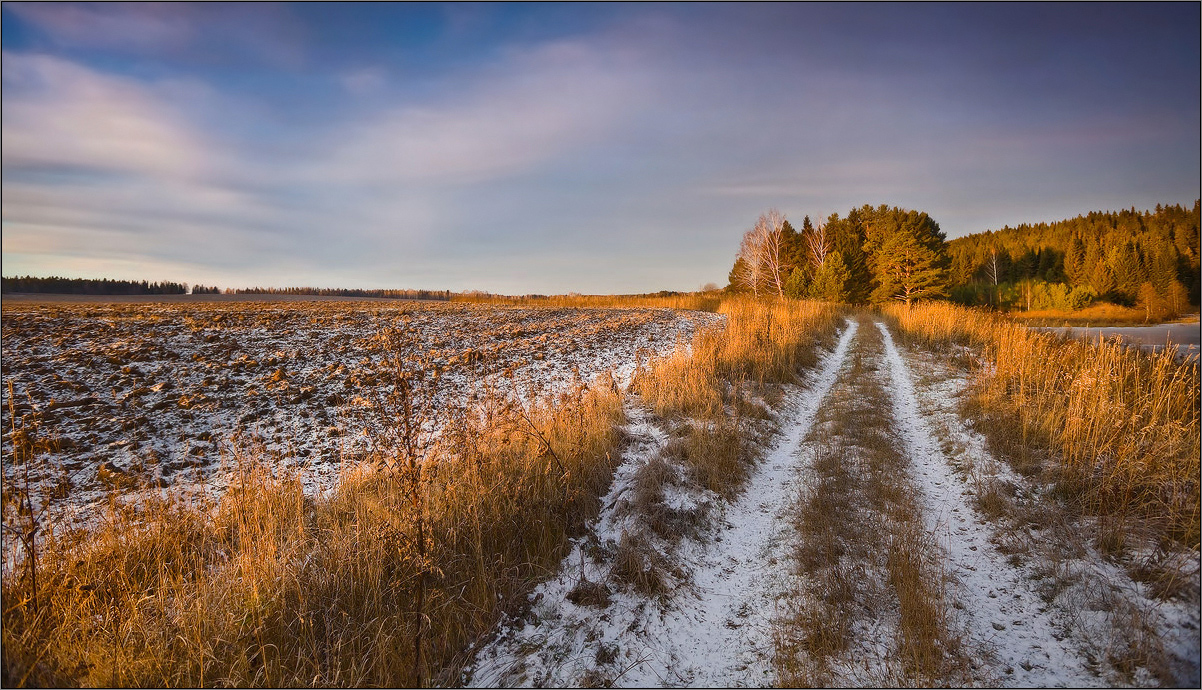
[465,317,1200,686]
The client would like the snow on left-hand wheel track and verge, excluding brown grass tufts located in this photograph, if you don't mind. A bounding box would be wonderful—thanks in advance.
[471,323,856,688]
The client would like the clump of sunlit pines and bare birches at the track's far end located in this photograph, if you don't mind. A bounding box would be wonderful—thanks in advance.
[727,204,950,303]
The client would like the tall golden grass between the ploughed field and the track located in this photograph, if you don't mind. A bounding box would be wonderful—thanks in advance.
[0,299,838,686]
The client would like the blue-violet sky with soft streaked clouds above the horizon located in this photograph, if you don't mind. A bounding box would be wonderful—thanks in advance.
[0,2,1202,295]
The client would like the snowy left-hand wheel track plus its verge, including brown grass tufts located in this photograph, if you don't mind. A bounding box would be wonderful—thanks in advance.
[469,326,855,688]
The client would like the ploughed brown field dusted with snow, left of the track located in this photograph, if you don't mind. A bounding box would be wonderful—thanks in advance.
[0,301,722,524]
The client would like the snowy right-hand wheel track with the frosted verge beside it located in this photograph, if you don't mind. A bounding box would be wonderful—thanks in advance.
[877,323,1200,688]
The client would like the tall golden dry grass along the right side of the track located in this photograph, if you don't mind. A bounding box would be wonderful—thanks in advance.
[885,303,1202,548]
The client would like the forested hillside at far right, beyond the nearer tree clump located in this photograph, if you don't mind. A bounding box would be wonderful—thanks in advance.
[947,201,1200,317]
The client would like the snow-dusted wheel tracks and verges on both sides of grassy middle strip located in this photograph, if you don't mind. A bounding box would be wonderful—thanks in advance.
[464,320,1200,686]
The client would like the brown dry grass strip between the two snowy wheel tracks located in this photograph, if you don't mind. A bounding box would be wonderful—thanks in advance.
[774,321,971,688]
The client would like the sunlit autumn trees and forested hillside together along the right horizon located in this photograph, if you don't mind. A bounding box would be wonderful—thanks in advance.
[727,201,1200,317]
